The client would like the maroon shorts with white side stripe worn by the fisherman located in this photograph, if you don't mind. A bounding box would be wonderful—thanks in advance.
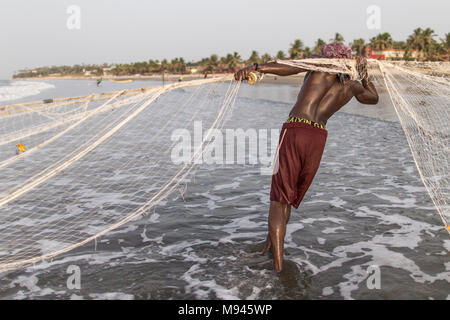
[270,122,328,208]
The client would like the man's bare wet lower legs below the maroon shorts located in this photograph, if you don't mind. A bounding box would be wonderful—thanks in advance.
[261,201,291,272]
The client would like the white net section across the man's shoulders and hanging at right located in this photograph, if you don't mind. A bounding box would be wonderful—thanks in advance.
[277,58,450,233]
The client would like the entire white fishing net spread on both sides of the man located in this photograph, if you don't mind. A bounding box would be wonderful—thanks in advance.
[0,59,450,272]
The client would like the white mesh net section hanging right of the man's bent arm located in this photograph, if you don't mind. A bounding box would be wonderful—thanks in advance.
[378,62,450,232]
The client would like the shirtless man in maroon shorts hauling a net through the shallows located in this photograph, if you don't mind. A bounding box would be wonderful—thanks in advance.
[235,44,378,272]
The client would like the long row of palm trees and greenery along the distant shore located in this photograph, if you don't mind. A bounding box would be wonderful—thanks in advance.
[13,28,450,78]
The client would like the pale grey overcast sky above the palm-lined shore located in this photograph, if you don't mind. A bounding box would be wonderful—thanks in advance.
[0,0,450,79]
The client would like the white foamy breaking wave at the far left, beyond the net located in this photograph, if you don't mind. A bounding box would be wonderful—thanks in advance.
[0,81,55,101]
